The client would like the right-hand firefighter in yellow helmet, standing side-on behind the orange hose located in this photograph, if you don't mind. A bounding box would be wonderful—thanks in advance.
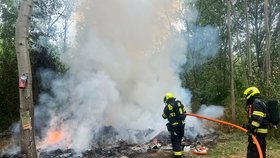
[243,87,269,158]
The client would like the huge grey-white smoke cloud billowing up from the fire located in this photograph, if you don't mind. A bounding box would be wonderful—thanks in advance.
[32,0,221,151]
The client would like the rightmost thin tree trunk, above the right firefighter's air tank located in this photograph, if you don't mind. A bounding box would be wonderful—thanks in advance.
[264,0,271,84]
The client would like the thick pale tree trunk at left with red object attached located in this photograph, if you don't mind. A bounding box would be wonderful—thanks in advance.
[15,0,37,158]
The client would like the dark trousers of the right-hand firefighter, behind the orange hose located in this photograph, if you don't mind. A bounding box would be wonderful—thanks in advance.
[247,133,266,158]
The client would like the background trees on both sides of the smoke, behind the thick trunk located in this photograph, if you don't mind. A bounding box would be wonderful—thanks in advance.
[0,0,280,138]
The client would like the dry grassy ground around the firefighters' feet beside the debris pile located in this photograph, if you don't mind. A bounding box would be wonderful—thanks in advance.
[0,132,280,158]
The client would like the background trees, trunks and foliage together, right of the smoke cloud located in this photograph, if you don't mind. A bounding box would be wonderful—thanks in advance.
[181,0,280,136]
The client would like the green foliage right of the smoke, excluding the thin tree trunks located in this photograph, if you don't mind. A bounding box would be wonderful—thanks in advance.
[180,0,280,137]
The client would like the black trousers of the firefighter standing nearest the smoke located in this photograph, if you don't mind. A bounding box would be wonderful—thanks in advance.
[170,124,185,158]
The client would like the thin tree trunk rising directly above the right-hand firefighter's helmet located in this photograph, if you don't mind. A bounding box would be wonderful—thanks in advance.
[244,0,252,87]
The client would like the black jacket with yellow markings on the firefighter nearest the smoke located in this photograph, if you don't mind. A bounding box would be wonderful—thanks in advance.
[162,100,186,126]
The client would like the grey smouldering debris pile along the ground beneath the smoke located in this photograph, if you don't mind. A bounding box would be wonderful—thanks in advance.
[1,126,218,158]
